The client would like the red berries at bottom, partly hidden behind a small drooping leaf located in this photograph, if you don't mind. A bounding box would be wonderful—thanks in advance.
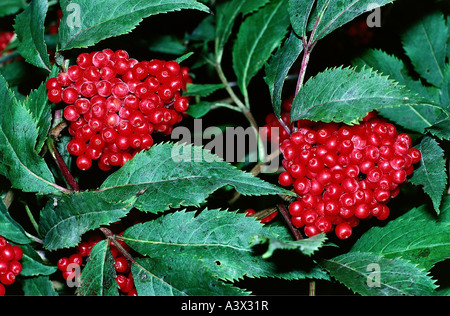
[57,234,137,296]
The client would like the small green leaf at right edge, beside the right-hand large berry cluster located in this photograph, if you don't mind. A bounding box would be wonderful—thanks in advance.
[410,136,447,214]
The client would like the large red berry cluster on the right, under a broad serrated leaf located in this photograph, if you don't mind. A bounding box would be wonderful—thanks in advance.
[278,113,421,239]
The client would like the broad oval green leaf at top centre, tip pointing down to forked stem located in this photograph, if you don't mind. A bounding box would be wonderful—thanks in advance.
[232,0,289,103]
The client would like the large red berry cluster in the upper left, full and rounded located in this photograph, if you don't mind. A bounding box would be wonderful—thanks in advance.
[46,49,191,171]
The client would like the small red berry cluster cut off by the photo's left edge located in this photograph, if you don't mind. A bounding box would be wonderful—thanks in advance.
[0,236,23,296]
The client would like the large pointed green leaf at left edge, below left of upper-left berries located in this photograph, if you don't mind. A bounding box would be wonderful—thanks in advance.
[0,75,62,194]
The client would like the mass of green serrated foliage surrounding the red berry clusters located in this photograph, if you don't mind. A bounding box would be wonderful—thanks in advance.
[0,0,450,296]
